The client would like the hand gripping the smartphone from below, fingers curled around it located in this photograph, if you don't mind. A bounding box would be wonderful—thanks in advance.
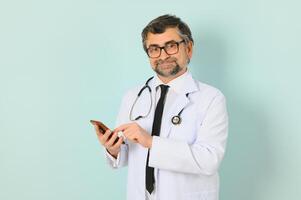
[94,125,123,158]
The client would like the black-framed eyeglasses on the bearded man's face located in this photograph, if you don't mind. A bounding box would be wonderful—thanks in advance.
[146,40,185,58]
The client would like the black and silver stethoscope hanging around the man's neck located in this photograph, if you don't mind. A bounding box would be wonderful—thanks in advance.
[129,77,189,125]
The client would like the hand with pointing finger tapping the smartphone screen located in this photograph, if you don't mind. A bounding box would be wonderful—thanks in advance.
[114,122,153,148]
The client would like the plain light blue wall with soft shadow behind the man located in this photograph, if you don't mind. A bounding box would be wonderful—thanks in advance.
[0,0,301,200]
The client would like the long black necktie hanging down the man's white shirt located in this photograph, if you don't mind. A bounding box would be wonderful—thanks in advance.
[145,85,169,194]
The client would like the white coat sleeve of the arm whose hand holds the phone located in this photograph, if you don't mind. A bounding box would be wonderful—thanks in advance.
[104,92,130,168]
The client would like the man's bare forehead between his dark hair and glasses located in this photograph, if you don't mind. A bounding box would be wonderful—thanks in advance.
[146,28,181,46]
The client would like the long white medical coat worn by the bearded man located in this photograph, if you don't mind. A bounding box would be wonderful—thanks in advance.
[107,74,228,200]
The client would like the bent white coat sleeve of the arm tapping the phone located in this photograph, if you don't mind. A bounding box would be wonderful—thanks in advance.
[149,93,228,175]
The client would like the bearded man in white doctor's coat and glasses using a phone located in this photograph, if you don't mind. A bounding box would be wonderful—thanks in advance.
[95,15,228,200]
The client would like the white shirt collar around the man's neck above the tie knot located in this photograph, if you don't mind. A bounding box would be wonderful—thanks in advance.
[154,69,190,93]
